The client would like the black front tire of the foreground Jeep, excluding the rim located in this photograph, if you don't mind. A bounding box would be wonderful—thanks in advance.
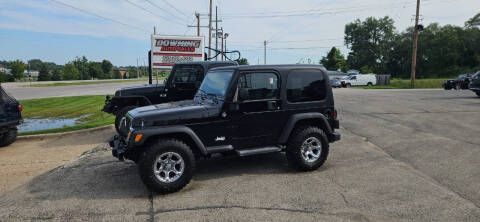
[138,139,195,194]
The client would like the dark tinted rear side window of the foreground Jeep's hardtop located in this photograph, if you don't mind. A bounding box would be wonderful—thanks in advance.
[287,69,327,103]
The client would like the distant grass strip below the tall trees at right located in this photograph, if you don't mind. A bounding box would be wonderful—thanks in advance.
[360,79,446,89]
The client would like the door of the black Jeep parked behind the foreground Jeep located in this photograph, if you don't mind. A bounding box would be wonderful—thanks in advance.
[167,65,204,101]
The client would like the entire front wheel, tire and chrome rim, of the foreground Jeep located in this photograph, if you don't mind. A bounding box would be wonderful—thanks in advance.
[139,139,195,194]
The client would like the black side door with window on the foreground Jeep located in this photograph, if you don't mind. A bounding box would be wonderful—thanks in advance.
[231,71,284,148]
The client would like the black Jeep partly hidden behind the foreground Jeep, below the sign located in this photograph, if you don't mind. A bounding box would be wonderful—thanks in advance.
[102,61,238,131]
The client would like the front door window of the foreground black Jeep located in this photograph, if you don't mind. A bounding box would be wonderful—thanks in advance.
[238,73,280,101]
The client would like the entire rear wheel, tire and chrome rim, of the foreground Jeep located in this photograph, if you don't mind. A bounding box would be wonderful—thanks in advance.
[286,126,328,171]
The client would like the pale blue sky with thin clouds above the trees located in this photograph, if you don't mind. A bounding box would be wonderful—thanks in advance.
[0,0,480,66]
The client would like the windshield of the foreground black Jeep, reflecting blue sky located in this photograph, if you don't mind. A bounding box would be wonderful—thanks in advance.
[195,70,233,100]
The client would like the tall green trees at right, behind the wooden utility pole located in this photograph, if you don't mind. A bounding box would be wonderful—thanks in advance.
[320,13,480,78]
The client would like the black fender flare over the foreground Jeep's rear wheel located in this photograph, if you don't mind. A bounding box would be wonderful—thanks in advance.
[278,113,333,144]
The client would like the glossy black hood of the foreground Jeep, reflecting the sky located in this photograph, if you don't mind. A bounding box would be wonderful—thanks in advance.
[124,100,221,127]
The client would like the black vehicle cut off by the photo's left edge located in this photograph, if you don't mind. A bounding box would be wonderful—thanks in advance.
[0,86,22,147]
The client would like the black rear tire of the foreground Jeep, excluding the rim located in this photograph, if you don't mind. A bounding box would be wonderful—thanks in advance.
[286,126,329,171]
